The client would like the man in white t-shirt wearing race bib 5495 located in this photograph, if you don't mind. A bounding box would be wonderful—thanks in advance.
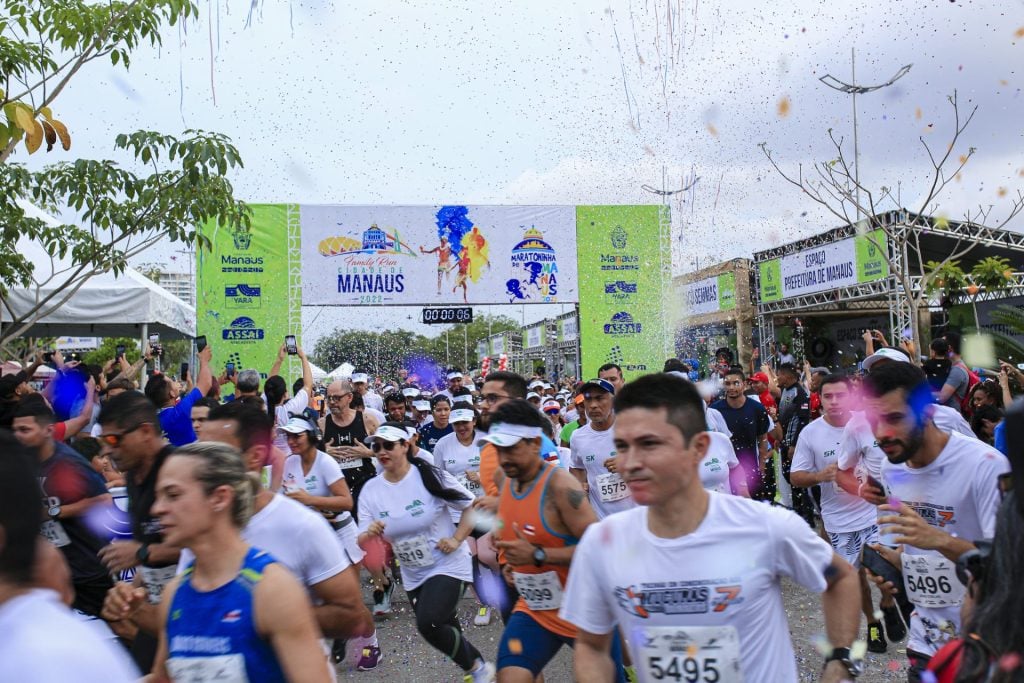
[561,374,862,683]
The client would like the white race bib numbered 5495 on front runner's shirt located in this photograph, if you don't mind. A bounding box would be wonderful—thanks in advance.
[635,626,743,683]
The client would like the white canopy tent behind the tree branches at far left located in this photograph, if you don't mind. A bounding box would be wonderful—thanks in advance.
[0,204,196,339]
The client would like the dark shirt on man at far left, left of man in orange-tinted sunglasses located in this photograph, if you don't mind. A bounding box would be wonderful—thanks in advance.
[39,443,110,584]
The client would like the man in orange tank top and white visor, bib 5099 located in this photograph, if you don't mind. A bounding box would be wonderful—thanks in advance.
[481,398,626,683]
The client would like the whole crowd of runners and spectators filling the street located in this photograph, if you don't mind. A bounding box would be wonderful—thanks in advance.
[0,333,1024,683]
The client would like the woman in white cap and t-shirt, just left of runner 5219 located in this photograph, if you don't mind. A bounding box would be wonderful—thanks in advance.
[282,417,362,564]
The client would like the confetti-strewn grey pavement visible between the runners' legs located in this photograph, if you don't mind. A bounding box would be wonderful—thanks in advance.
[338,583,906,683]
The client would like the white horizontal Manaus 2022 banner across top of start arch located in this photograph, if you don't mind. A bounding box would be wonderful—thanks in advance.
[301,206,579,306]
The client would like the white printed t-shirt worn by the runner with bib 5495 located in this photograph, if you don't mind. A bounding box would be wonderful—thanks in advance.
[561,493,833,683]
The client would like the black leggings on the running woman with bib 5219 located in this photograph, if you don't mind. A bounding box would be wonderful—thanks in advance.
[408,575,483,672]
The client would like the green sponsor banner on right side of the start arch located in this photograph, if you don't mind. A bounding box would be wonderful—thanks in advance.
[577,206,671,378]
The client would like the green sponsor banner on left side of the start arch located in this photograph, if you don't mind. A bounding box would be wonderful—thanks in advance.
[196,204,302,377]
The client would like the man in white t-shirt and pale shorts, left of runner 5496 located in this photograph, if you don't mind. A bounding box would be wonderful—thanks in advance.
[790,375,886,652]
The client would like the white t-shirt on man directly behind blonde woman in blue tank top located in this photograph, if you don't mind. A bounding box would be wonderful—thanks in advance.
[178,494,351,588]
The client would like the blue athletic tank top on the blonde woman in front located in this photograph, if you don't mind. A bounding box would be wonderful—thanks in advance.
[167,548,285,683]
